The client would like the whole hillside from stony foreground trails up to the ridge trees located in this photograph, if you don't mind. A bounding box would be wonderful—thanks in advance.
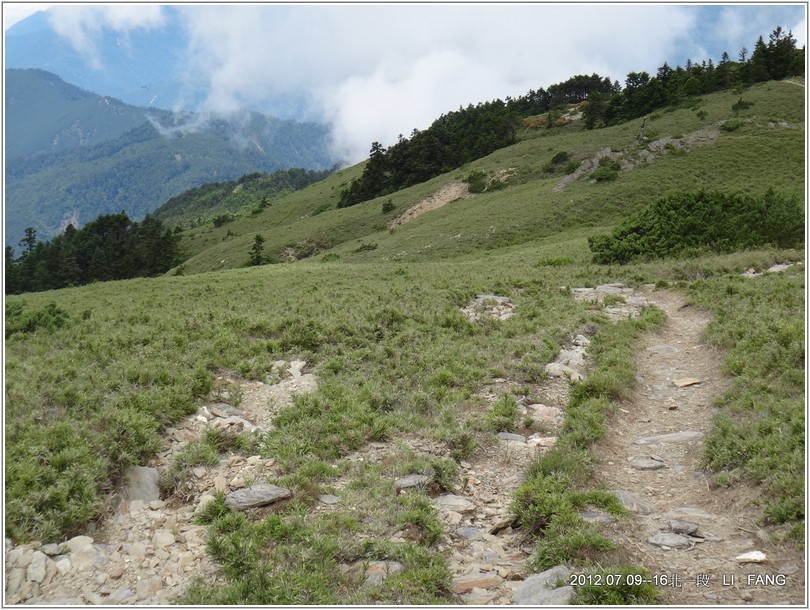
[5,78,806,606]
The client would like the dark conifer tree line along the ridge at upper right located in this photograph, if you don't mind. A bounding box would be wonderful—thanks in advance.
[338,27,804,207]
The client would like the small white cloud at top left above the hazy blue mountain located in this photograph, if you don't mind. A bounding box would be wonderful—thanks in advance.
[46,4,164,70]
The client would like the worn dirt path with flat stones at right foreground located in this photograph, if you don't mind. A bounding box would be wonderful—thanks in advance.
[594,291,805,605]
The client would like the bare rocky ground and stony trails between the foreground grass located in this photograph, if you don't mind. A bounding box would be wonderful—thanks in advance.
[5,269,805,605]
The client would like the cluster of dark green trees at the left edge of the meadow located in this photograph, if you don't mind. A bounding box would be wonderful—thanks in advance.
[5,212,180,294]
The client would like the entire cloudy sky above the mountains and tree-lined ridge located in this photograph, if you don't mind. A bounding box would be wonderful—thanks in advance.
[3,2,807,162]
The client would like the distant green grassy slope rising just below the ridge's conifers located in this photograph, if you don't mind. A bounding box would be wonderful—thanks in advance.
[175,82,804,273]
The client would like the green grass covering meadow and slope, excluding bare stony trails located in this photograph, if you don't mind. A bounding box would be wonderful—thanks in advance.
[5,77,804,604]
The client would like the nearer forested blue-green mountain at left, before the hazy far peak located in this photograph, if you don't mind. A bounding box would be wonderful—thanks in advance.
[5,69,336,245]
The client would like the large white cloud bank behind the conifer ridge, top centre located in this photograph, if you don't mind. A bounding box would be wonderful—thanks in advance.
[169,5,692,161]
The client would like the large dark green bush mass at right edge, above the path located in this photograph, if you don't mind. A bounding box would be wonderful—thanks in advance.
[588,189,804,264]
